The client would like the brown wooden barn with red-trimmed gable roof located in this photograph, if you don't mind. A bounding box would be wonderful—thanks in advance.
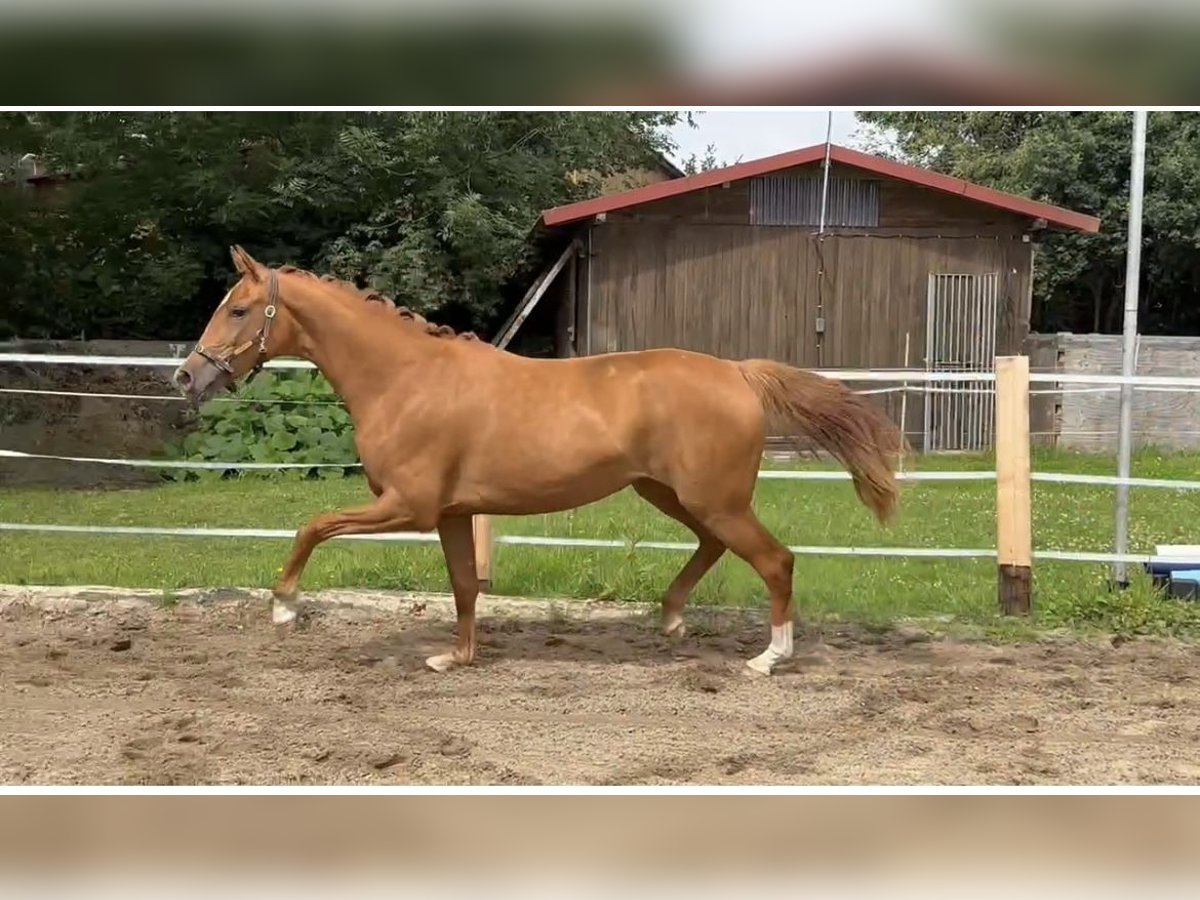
[502,144,1099,450]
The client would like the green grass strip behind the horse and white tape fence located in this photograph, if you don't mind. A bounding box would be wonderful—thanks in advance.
[0,451,1200,636]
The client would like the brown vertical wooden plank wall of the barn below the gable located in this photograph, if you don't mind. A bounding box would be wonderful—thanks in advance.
[584,224,1032,440]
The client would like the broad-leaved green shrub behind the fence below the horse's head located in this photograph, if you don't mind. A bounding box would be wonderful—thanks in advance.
[164,370,358,480]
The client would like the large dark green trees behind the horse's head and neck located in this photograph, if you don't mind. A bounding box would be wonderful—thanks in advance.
[0,112,678,338]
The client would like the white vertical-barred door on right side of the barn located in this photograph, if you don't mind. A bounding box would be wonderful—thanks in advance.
[924,272,1000,452]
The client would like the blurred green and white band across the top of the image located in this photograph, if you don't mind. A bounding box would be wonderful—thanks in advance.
[0,0,1200,106]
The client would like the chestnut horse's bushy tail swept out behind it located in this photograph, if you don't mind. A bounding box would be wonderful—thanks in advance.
[738,359,906,523]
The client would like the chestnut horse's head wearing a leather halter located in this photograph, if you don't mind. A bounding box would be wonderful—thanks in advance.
[175,246,280,403]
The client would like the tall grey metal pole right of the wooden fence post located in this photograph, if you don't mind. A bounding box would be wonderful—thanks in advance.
[1112,109,1146,588]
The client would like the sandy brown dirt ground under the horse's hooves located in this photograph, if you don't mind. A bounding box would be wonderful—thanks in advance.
[0,590,1200,785]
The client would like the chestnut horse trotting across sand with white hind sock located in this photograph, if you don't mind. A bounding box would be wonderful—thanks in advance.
[175,247,904,674]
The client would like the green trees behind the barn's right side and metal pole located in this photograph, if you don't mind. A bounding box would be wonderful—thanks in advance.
[858,112,1200,334]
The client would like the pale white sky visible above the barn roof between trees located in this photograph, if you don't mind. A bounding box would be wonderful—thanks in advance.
[671,109,878,164]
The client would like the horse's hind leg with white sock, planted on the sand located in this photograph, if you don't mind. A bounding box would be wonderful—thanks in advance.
[695,508,794,674]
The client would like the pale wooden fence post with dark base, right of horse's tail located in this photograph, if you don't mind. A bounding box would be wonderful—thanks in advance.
[996,356,1033,616]
